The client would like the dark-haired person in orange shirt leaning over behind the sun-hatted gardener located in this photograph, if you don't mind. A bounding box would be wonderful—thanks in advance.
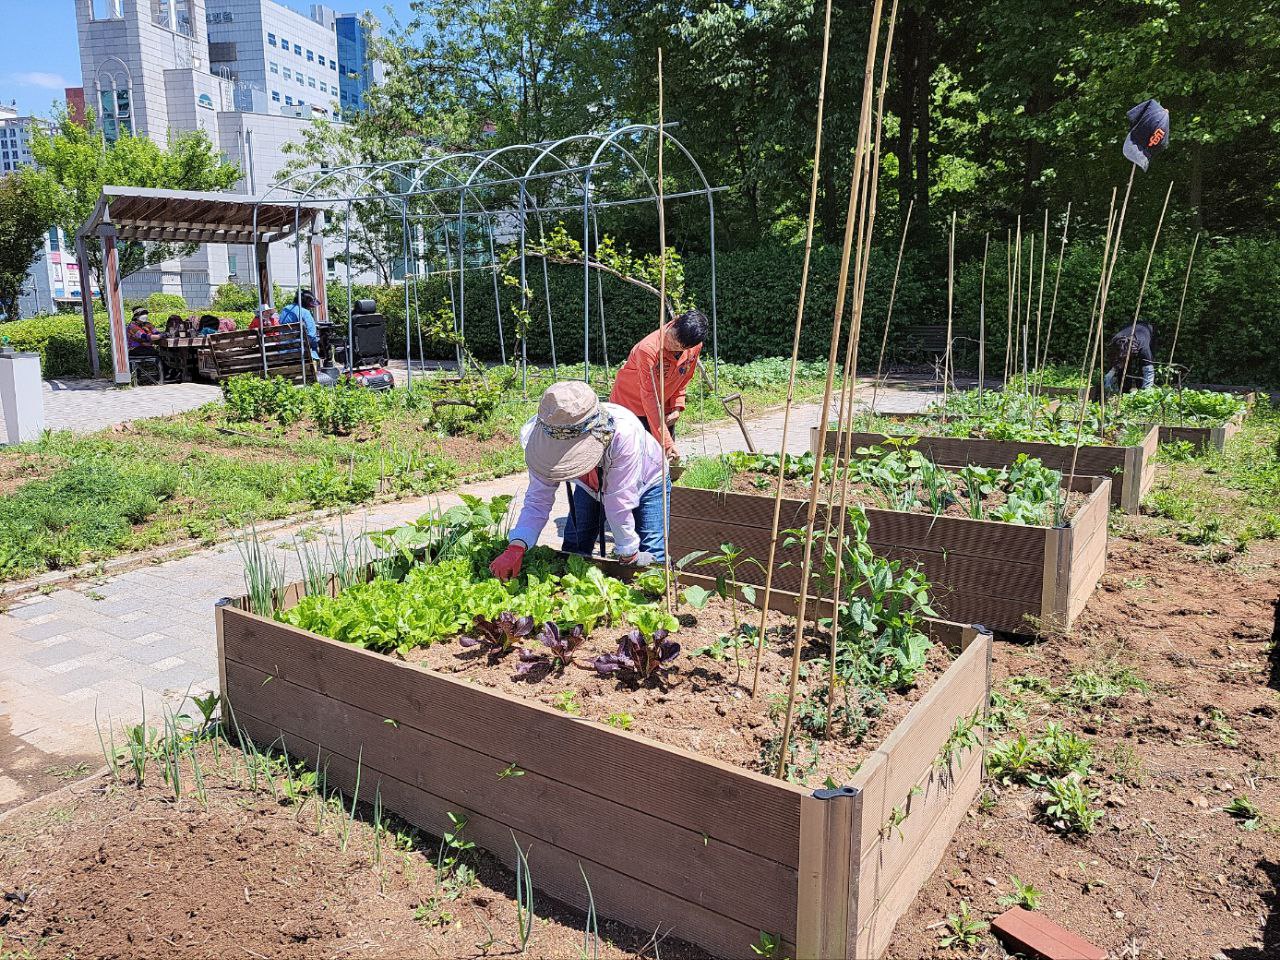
[609,310,708,461]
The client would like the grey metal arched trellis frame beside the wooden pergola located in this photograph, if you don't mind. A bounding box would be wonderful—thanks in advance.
[251,123,724,389]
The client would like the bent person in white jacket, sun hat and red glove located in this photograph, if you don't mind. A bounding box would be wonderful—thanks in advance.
[489,380,671,580]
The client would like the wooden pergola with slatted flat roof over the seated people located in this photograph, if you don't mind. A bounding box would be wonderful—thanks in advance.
[76,187,329,384]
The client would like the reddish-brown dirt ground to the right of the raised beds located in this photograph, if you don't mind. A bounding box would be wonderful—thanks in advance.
[890,529,1280,960]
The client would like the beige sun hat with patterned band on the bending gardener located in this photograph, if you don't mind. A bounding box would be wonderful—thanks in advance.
[525,380,613,484]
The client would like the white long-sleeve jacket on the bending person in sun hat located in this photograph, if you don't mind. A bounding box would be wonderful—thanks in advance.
[511,403,663,556]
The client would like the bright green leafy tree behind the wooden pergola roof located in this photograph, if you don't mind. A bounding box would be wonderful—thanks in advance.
[31,115,241,305]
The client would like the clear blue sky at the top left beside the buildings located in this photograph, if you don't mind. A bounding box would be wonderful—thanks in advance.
[0,0,410,115]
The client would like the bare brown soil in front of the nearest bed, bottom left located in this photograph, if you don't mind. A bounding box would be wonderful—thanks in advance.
[0,748,700,960]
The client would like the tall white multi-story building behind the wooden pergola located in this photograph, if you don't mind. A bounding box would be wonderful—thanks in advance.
[76,0,376,306]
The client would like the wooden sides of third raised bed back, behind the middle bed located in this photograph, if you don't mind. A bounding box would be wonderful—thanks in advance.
[809,426,1161,513]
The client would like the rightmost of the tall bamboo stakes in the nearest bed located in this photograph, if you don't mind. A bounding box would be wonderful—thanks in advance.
[814,0,897,740]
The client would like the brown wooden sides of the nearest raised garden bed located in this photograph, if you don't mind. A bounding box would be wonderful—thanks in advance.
[216,568,991,960]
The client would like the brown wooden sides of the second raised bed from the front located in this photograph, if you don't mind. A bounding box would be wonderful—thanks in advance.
[671,476,1111,634]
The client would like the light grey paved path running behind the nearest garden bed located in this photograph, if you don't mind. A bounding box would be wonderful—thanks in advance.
[0,384,932,810]
